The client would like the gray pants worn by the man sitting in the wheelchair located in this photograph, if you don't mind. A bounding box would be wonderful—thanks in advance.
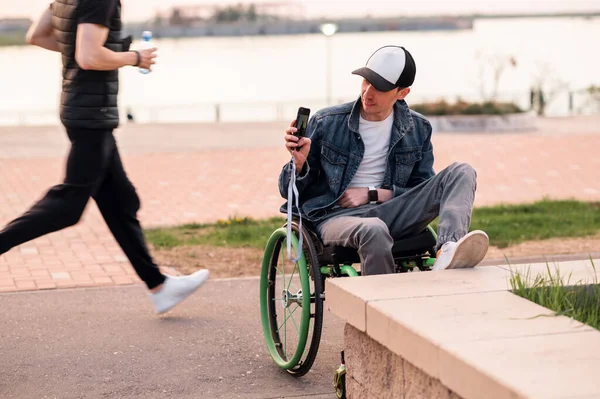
[317,163,477,275]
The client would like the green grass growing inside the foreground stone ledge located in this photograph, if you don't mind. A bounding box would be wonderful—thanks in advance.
[510,259,600,330]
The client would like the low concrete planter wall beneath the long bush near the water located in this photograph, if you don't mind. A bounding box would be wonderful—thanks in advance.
[427,112,537,133]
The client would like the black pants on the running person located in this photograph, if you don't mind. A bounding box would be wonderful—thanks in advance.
[0,129,165,288]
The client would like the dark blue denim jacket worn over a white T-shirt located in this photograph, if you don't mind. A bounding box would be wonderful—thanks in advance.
[279,98,434,222]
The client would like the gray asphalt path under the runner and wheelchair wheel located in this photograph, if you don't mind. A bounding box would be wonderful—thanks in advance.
[0,279,343,399]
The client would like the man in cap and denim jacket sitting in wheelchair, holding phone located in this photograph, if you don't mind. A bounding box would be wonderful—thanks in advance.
[279,46,489,275]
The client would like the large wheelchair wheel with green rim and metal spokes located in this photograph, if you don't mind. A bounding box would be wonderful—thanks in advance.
[260,222,324,377]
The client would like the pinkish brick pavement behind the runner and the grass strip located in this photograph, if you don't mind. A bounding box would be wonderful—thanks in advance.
[0,117,600,292]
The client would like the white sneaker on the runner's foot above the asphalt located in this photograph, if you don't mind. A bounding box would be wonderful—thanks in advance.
[150,269,209,314]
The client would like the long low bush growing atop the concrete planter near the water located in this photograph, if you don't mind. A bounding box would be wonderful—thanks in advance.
[410,100,523,116]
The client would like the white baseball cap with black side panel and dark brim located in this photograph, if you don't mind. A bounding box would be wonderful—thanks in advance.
[352,46,417,91]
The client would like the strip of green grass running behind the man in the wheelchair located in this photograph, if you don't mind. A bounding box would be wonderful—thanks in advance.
[146,201,600,248]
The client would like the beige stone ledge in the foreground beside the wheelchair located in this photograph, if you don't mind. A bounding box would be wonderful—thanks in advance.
[325,260,600,399]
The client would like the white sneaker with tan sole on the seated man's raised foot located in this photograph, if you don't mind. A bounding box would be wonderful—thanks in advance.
[431,230,490,271]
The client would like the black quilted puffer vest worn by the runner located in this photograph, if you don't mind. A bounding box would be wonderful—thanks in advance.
[52,0,129,129]
